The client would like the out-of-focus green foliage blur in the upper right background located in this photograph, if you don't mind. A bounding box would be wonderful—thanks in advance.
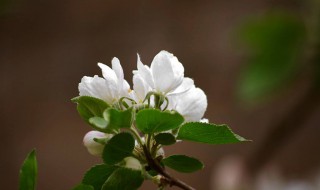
[239,14,305,101]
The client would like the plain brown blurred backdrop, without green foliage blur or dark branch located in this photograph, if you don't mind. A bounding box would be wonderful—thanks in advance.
[0,0,320,190]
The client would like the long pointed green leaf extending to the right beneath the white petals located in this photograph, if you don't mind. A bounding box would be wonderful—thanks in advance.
[177,122,248,144]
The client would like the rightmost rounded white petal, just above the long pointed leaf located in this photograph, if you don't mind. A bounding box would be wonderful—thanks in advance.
[169,87,208,122]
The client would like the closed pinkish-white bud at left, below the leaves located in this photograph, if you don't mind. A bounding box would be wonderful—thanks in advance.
[83,131,112,156]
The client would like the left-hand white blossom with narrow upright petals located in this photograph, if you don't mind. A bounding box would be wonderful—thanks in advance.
[79,57,130,104]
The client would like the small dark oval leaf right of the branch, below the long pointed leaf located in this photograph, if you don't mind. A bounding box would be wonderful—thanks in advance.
[161,155,204,173]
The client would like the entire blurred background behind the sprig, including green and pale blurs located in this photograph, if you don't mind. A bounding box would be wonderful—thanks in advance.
[0,0,320,190]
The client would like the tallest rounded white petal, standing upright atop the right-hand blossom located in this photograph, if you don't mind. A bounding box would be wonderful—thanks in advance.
[151,51,184,93]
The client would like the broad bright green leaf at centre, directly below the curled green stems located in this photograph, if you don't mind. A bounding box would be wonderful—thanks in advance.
[136,109,184,134]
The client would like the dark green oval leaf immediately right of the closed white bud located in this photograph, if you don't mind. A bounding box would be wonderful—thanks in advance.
[102,133,135,165]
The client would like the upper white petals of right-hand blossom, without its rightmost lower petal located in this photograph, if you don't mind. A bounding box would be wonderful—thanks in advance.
[133,51,193,98]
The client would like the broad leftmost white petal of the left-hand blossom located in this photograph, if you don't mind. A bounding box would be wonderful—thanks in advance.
[78,75,113,103]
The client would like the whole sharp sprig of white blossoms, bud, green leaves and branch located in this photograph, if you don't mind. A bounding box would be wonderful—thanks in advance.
[68,51,247,190]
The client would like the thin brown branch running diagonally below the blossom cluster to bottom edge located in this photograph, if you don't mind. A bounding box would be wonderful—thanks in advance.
[143,145,195,190]
